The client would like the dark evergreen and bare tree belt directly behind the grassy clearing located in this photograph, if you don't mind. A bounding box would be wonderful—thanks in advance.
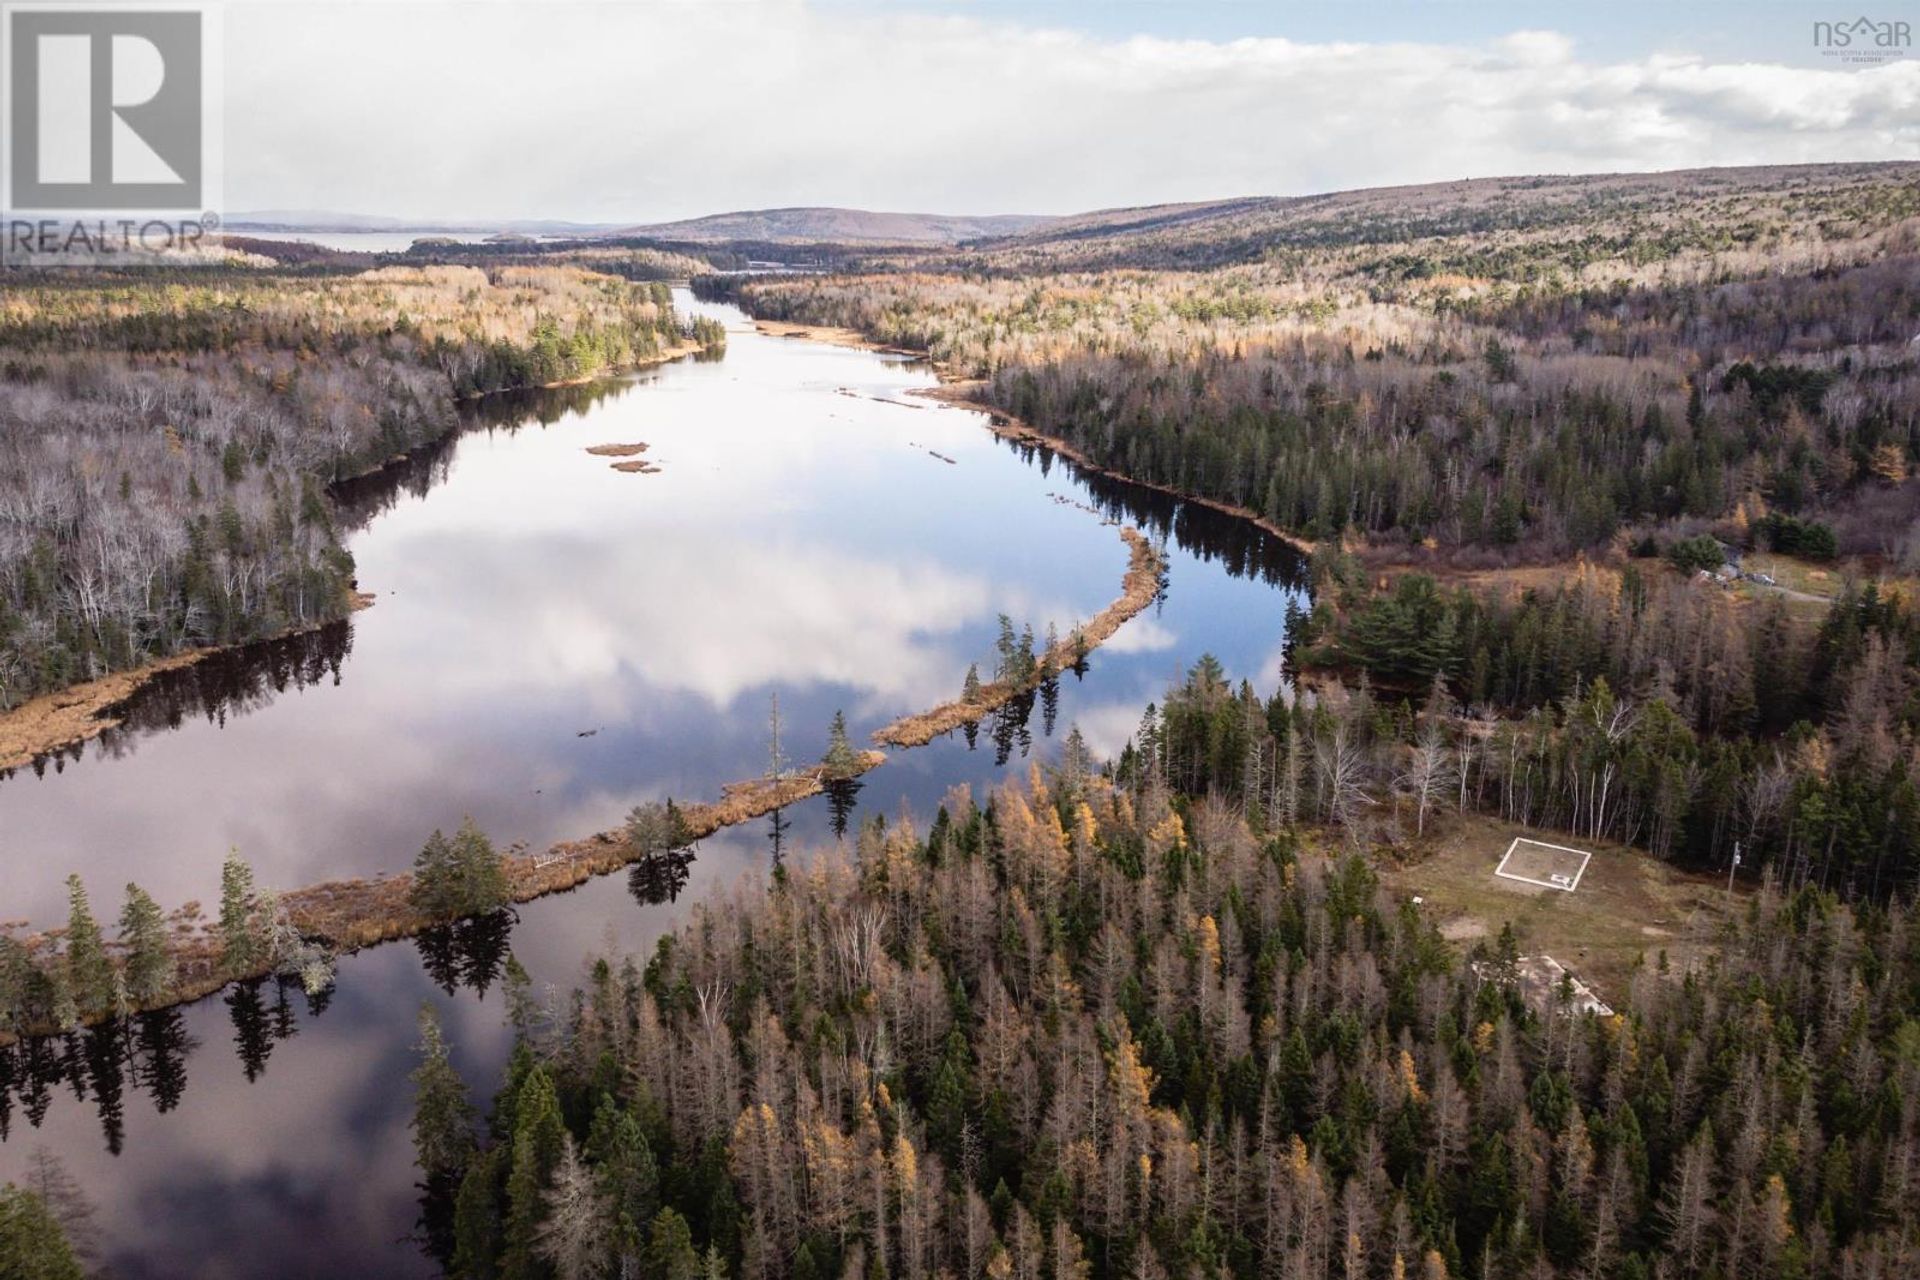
[1123,548,1920,898]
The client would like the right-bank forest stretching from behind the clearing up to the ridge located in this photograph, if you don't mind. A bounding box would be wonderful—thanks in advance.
[697,165,1920,896]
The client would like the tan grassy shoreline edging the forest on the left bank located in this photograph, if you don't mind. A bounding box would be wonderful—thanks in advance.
[0,342,705,779]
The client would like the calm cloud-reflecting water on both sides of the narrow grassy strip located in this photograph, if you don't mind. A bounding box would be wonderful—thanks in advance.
[0,296,1298,1278]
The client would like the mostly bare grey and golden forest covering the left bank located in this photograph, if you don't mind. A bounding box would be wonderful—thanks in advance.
[0,267,720,710]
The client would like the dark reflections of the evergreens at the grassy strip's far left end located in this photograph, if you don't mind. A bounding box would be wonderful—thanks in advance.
[0,1009,196,1155]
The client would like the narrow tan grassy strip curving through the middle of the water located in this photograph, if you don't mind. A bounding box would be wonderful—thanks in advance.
[0,526,1162,1044]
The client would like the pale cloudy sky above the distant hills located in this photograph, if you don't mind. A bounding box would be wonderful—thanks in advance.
[221,0,1920,223]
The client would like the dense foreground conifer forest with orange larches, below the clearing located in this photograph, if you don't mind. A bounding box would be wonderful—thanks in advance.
[413,768,1920,1280]
